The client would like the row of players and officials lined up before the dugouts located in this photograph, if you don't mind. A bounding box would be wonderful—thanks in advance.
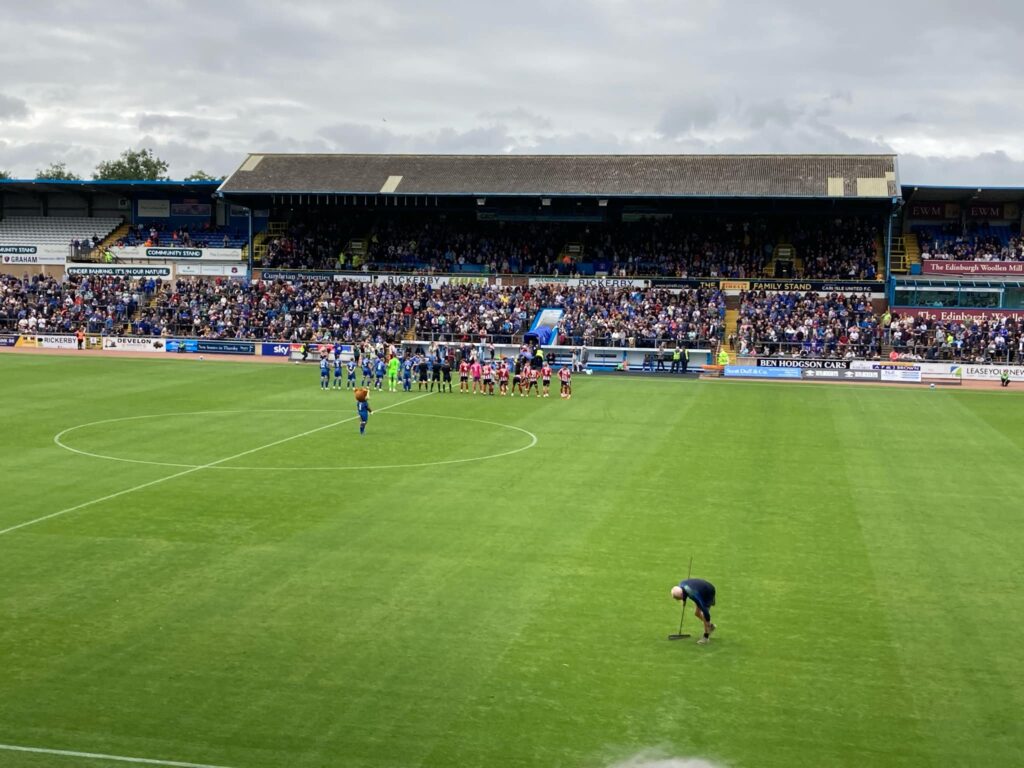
[319,347,572,399]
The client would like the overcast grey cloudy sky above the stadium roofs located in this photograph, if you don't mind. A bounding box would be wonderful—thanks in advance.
[0,0,1024,186]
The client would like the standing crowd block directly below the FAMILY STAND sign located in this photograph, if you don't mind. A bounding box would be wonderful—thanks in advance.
[729,291,881,358]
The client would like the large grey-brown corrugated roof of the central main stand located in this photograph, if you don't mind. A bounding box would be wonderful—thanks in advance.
[219,155,900,200]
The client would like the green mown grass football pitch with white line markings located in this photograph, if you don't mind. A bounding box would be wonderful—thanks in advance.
[0,355,1024,768]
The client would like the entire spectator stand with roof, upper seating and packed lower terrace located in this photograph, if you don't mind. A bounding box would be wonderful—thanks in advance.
[0,154,1024,368]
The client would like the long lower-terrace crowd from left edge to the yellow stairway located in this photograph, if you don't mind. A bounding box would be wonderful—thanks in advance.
[0,275,725,346]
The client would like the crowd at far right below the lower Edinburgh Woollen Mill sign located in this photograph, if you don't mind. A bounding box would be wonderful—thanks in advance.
[883,315,1024,365]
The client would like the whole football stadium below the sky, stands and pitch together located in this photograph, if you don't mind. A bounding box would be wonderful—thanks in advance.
[0,154,1024,768]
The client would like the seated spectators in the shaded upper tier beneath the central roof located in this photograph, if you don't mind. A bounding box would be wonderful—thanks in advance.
[253,214,879,280]
